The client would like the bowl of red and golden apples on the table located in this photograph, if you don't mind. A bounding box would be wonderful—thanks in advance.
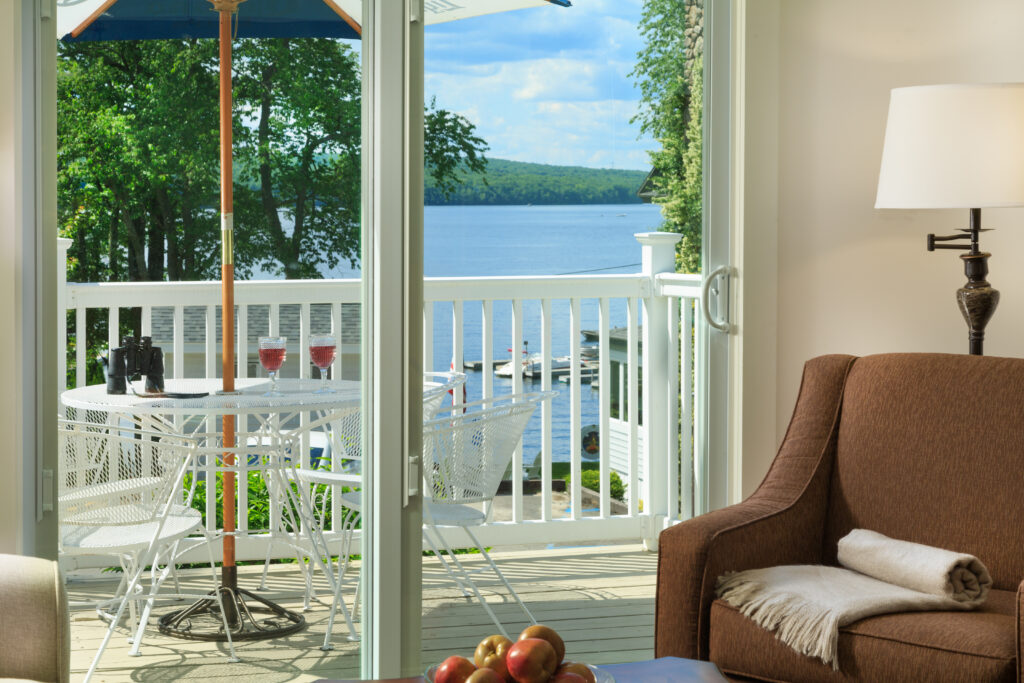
[426,624,614,683]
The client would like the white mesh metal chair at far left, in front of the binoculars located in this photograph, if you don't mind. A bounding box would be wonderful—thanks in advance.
[57,420,237,681]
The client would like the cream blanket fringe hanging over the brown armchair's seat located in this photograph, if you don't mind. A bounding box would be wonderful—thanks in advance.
[716,572,840,671]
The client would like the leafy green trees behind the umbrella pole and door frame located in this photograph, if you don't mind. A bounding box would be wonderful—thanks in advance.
[57,39,487,282]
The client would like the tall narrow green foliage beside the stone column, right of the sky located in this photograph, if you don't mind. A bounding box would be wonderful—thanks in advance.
[632,0,703,272]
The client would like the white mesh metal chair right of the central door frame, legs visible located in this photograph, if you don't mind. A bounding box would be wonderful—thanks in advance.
[423,391,557,637]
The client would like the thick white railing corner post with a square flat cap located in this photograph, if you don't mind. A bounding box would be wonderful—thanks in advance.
[635,232,681,551]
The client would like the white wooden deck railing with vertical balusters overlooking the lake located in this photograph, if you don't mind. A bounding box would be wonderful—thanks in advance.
[57,233,705,559]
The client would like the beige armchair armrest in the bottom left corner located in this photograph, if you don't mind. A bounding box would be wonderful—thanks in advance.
[0,555,71,683]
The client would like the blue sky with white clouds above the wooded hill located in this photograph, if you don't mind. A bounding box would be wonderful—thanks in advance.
[424,0,656,170]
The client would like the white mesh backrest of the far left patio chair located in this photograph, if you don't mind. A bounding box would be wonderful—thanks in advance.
[57,420,196,526]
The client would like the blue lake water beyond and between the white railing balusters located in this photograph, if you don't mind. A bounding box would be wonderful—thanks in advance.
[326,204,662,466]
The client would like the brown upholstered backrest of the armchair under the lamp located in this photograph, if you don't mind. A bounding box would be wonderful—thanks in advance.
[823,353,1024,590]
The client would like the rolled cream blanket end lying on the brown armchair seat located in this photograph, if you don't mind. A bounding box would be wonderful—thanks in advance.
[839,528,992,607]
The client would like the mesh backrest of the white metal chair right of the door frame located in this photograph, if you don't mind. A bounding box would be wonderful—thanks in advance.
[423,391,557,504]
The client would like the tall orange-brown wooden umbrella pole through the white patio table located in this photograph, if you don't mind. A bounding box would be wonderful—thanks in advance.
[214,0,239,591]
